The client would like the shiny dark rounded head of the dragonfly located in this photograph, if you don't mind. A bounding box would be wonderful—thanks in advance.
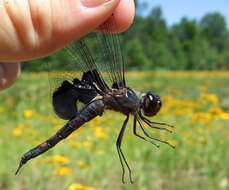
[141,92,162,117]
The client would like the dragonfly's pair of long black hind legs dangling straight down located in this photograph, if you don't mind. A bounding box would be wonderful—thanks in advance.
[116,115,133,183]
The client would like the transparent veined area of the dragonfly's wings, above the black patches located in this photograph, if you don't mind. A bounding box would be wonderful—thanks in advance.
[48,15,125,95]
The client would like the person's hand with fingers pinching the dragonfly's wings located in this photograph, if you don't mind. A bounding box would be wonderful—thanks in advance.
[0,0,135,90]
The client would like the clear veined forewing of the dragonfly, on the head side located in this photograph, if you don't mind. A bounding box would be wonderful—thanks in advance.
[66,15,125,91]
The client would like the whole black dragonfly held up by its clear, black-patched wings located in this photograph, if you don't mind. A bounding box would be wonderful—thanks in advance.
[15,15,174,183]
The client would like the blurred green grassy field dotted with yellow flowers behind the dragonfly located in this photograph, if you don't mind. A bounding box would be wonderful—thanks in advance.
[0,71,229,190]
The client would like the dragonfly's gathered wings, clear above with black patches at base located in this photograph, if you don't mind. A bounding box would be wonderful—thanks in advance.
[48,16,125,119]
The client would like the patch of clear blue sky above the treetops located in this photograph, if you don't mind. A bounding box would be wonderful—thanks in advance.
[140,0,229,27]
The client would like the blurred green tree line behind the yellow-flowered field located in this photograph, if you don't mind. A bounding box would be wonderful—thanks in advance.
[23,7,229,71]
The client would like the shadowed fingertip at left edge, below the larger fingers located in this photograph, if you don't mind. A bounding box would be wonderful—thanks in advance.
[0,63,20,90]
